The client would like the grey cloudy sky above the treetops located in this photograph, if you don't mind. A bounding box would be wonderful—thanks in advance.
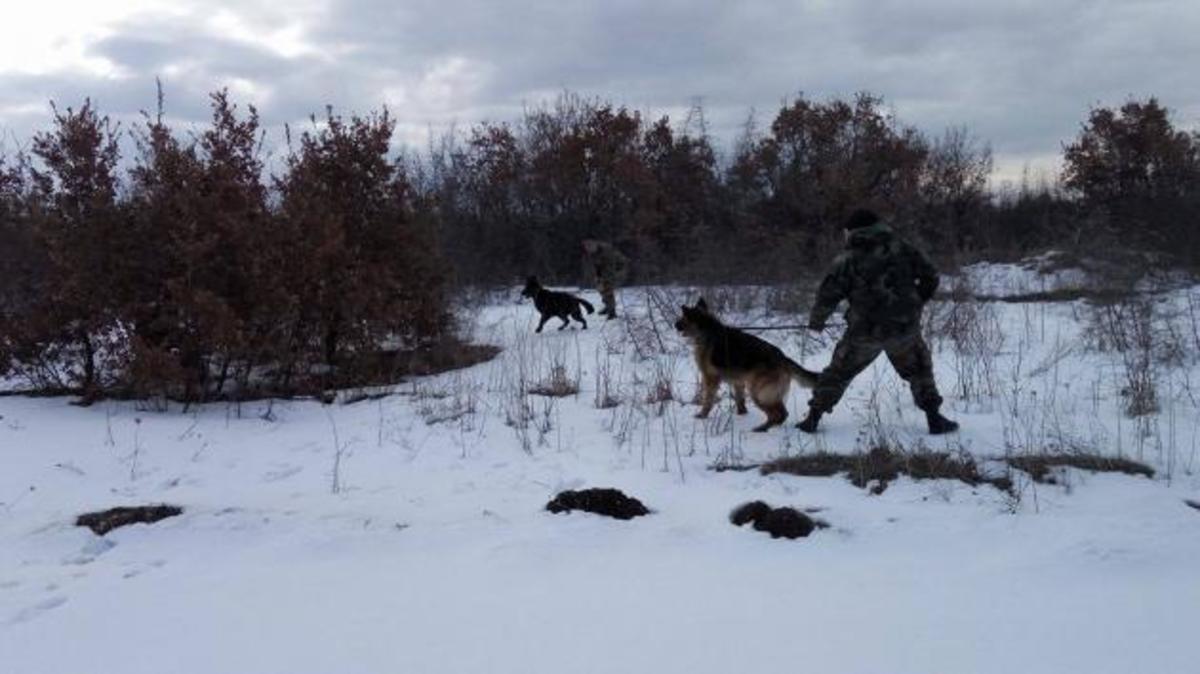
[0,0,1200,182]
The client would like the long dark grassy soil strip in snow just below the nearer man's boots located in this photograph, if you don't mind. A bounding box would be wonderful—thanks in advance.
[758,447,1013,494]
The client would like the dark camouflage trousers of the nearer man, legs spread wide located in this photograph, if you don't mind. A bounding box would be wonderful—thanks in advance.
[809,330,942,413]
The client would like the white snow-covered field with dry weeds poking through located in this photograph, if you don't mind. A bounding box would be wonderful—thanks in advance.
[0,269,1200,674]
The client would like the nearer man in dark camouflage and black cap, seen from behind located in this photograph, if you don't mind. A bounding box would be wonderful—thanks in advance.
[797,210,959,434]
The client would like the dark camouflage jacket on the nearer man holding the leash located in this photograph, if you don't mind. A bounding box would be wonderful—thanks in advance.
[809,223,937,337]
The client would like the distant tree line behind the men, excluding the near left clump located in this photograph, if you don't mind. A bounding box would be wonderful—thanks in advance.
[427,94,1200,283]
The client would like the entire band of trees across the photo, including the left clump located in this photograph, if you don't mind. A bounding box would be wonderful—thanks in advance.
[0,85,1200,401]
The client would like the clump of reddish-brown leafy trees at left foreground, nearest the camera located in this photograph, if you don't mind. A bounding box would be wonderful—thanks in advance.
[0,92,450,401]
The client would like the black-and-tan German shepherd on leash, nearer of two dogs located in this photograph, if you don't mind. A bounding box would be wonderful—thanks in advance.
[676,297,817,433]
